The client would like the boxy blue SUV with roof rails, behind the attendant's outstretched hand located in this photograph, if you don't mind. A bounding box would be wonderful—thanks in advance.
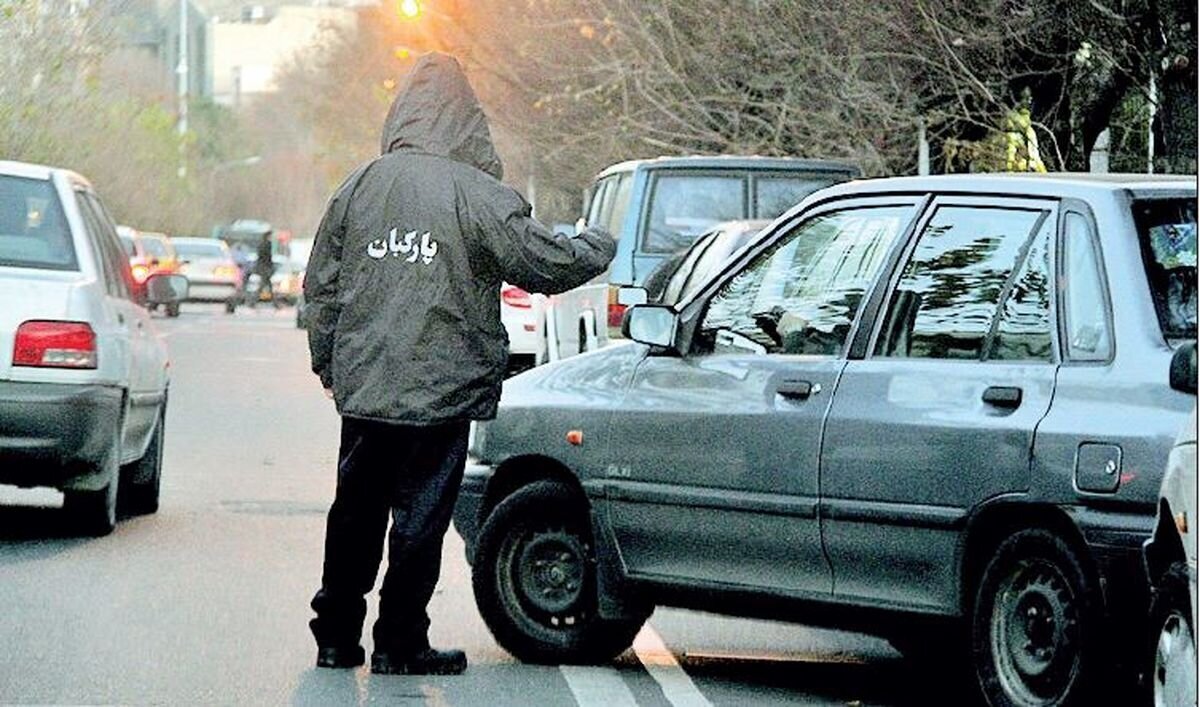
[539,156,859,360]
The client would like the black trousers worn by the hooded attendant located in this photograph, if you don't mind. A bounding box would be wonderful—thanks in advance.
[308,418,469,654]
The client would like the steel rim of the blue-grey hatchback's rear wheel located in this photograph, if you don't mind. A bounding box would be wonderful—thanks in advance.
[990,562,1080,707]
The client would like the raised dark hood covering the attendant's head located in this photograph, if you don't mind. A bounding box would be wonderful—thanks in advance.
[380,53,504,179]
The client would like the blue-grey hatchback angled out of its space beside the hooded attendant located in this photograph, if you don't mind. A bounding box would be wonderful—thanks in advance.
[455,174,1196,707]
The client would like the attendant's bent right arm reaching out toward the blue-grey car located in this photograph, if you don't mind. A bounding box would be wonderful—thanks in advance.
[473,184,617,294]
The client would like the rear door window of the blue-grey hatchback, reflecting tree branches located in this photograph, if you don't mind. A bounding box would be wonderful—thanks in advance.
[875,206,1051,360]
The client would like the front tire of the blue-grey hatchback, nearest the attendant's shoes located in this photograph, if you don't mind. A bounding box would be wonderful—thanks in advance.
[472,481,646,664]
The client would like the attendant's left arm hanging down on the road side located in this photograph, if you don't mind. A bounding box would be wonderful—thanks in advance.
[304,167,366,390]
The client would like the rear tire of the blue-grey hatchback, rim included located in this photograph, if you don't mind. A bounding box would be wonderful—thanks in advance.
[971,529,1104,707]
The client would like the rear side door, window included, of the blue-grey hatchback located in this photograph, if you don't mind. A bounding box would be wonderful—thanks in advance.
[821,197,1057,610]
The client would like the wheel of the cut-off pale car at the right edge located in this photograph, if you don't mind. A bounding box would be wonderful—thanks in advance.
[1146,562,1196,707]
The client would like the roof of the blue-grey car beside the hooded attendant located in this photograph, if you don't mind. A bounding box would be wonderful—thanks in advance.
[815,172,1196,200]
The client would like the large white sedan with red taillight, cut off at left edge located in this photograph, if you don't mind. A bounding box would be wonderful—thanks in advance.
[0,161,187,535]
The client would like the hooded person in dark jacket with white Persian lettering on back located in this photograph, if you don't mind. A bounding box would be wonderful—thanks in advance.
[304,54,616,673]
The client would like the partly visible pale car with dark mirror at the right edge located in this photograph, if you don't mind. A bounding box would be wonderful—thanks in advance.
[1145,343,1200,707]
